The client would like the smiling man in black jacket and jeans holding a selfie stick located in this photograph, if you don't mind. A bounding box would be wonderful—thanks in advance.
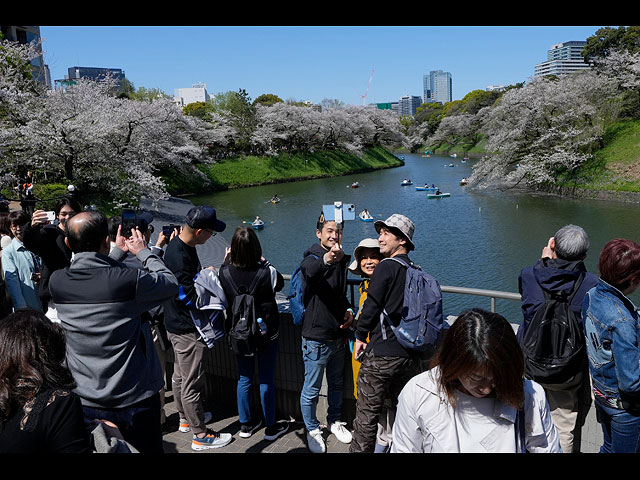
[300,215,353,453]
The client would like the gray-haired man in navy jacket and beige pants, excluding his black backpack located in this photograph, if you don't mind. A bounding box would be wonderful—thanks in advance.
[517,225,598,453]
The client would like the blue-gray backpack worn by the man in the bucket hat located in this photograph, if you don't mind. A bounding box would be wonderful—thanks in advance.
[380,257,444,353]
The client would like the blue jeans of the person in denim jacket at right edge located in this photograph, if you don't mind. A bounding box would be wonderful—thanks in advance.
[594,398,640,453]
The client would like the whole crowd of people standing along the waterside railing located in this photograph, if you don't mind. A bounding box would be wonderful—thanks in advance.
[0,191,640,453]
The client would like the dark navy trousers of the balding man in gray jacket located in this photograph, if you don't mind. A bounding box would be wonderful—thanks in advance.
[82,393,164,453]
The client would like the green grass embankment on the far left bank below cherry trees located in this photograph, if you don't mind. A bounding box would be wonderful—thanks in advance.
[163,147,404,195]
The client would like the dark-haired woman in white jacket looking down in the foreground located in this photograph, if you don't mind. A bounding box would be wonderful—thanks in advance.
[391,309,562,453]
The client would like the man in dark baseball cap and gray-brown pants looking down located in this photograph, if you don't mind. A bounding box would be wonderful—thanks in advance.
[164,206,231,450]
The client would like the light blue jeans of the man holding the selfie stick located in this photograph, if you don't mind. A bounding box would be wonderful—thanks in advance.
[300,337,345,431]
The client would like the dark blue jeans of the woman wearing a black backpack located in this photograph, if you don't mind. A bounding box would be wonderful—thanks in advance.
[236,340,278,427]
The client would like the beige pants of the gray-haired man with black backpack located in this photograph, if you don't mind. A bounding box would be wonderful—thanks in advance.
[542,370,591,453]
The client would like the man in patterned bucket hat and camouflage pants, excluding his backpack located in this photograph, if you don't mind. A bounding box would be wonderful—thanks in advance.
[350,214,421,453]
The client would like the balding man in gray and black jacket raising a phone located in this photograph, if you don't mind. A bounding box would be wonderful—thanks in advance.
[50,211,178,453]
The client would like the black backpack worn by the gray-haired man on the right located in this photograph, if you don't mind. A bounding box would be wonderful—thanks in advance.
[521,274,585,384]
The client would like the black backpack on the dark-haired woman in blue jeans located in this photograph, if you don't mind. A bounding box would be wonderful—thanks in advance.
[220,267,269,356]
